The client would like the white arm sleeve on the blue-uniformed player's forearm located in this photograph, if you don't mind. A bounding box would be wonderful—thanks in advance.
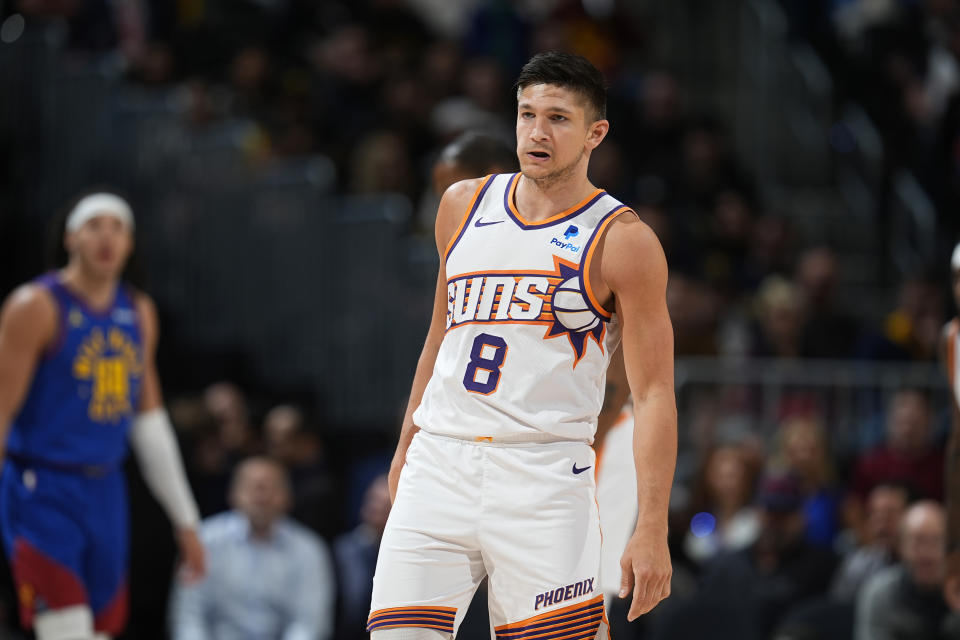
[130,409,200,529]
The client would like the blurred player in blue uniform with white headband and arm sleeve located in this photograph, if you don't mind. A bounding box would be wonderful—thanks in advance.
[0,193,204,640]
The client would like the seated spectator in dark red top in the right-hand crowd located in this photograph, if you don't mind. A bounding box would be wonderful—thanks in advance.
[852,389,943,501]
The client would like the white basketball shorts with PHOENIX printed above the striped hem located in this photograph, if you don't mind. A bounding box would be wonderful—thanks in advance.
[367,431,608,640]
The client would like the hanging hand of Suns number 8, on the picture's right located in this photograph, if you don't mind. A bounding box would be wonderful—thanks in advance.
[620,530,673,622]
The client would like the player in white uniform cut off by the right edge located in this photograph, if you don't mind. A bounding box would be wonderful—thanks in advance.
[940,243,960,611]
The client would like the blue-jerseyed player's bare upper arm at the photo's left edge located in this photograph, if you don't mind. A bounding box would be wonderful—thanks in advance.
[0,285,57,466]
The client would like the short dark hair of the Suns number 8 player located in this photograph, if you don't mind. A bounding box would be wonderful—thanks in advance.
[515,51,607,120]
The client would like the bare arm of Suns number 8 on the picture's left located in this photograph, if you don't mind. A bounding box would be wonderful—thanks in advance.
[389,178,483,502]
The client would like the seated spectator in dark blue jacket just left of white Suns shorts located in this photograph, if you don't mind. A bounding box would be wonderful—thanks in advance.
[333,475,390,640]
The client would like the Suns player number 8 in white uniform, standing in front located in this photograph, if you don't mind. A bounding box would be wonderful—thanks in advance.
[368,53,676,640]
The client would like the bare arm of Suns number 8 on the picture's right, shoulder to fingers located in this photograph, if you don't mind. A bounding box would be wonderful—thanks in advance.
[591,214,677,620]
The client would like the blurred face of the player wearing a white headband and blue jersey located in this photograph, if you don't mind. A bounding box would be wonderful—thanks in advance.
[66,215,133,278]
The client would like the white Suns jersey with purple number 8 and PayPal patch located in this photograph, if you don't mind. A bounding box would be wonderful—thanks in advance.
[413,174,628,443]
